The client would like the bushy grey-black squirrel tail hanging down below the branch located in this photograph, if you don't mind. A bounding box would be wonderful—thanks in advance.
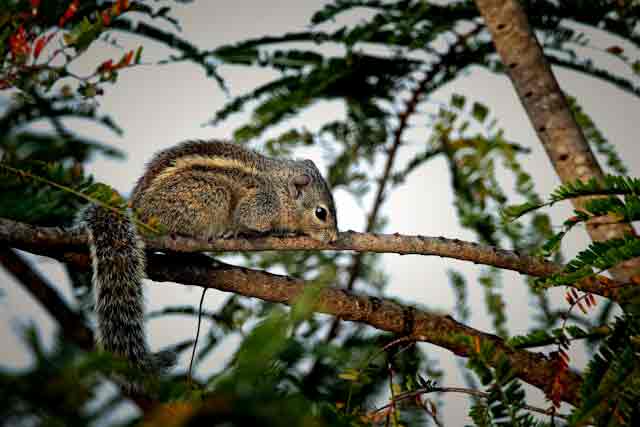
[78,205,175,389]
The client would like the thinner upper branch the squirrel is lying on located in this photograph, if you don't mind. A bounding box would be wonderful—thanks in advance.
[0,218,623,300]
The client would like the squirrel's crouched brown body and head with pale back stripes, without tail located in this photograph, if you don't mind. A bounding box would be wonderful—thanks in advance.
[130,141,337,241]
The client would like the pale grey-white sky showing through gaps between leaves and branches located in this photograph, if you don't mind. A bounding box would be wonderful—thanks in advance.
[0,0,640,425]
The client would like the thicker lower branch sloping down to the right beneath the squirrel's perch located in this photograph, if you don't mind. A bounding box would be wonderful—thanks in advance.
[0,220,582,404]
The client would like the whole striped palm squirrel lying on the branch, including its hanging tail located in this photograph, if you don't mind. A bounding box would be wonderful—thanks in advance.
[77,141,338,391]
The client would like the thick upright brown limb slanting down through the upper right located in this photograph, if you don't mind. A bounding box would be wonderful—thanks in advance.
[476,0,640,282]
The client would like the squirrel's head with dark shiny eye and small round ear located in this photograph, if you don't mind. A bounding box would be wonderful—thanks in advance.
[288,160,338,243]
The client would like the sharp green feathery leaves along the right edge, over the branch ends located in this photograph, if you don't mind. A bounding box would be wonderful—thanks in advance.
[511,176,640,425]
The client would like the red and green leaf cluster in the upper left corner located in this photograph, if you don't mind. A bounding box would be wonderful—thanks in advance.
[0,0,145,94]
